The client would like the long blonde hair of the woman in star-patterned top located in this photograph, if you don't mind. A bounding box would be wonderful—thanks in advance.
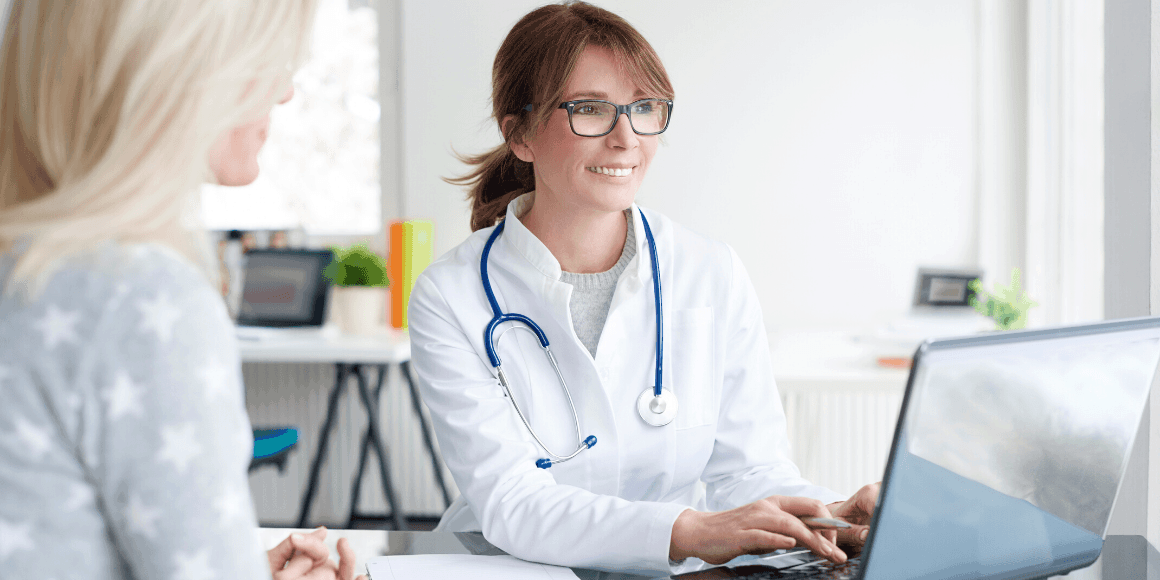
[0,0,317,292]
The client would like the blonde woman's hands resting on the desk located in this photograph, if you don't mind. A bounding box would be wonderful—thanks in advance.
[266,528,367,580]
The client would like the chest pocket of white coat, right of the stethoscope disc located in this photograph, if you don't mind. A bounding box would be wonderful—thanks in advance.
[668,306,717,429]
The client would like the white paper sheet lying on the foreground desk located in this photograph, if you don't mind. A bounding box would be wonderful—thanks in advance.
[367,553,579,580]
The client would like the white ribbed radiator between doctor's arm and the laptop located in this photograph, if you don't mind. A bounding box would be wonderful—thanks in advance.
[782,389,902,495]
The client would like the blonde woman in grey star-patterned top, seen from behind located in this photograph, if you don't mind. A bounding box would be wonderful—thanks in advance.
[0,0,354,580]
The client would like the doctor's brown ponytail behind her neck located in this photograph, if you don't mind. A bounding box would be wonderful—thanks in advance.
[443,143,536,232]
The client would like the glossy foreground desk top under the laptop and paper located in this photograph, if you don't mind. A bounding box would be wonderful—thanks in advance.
[260,528,1160,580]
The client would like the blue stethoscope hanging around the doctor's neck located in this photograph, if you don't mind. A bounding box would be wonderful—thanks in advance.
[479,212,677,469]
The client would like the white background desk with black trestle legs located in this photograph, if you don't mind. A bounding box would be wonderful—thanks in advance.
[239,328,451,530]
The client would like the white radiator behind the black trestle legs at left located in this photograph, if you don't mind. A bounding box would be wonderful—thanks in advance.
[242,363,458,527]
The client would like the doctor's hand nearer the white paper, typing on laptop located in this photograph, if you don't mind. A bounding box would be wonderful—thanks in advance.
[668,495,846,564]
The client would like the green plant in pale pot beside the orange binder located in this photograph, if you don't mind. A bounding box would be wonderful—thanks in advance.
[322,244,391,334]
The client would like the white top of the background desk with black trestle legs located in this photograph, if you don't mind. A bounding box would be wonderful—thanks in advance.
[238,327,411,364]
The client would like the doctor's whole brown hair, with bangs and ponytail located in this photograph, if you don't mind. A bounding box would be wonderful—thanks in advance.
[443,1,673,231]
